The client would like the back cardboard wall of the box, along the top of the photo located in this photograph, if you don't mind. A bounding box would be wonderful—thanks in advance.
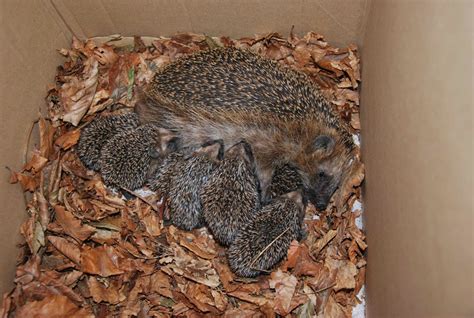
[52,0,369,45]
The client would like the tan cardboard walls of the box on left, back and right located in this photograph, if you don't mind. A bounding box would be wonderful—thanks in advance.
[0,0,474,317]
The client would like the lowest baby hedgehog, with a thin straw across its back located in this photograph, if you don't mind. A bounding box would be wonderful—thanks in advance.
[227,191,304,277]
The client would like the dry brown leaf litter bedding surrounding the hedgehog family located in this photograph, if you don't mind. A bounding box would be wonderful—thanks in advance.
[0,32,367,317]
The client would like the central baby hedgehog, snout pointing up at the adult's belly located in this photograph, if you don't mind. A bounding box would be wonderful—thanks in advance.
[201,141,260,246]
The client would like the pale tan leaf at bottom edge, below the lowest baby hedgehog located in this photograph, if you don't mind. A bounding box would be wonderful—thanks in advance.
[269,270,298,316]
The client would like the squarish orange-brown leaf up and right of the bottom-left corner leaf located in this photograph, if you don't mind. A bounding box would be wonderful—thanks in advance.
[81,245,124,277]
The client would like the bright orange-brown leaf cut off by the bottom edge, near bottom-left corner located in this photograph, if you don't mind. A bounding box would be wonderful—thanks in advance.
[16,295,94,318]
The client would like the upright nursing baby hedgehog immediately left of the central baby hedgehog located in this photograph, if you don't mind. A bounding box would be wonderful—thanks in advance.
[150,140,223,231]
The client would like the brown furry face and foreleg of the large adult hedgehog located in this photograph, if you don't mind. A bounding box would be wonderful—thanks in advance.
[249,120,354,210]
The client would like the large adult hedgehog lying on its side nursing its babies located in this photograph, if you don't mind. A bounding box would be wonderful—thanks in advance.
[135,48,354,209]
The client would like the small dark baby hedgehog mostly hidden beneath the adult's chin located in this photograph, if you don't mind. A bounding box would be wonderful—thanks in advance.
[263,163,303,203]
